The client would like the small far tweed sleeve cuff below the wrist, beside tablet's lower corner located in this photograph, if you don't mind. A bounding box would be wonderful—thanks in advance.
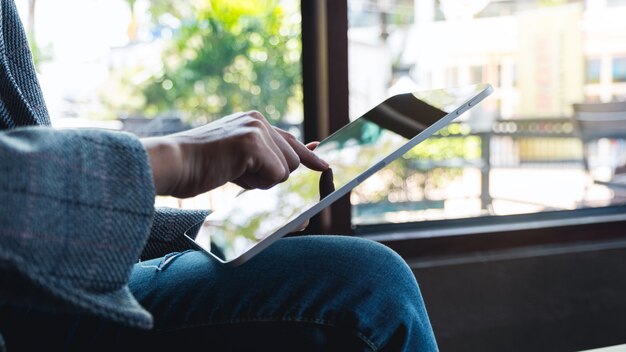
[141,207,210,260]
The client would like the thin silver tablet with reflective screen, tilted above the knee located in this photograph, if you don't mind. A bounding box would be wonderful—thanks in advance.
[185,84,493,265]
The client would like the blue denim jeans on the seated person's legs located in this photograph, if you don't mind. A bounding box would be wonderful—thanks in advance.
[0,236,437,352]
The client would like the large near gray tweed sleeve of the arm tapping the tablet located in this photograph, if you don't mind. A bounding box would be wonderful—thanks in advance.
[0,127,154,328]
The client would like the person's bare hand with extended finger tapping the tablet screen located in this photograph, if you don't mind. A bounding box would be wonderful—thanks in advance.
[142,111,328,198]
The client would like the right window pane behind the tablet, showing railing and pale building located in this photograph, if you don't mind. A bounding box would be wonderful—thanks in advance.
[348,0,626,225]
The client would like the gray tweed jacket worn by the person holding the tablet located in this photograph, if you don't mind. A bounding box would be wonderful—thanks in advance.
[0,0,207,351]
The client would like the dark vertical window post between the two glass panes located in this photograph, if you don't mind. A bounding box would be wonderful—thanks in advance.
[300,0,353,234]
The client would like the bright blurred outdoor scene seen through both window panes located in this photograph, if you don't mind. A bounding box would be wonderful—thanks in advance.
[16,0,626,225]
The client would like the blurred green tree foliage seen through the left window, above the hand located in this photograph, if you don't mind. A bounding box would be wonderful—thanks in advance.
[108,0,302,123]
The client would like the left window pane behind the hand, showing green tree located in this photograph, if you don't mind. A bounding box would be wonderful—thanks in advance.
[16,0,303,208]
